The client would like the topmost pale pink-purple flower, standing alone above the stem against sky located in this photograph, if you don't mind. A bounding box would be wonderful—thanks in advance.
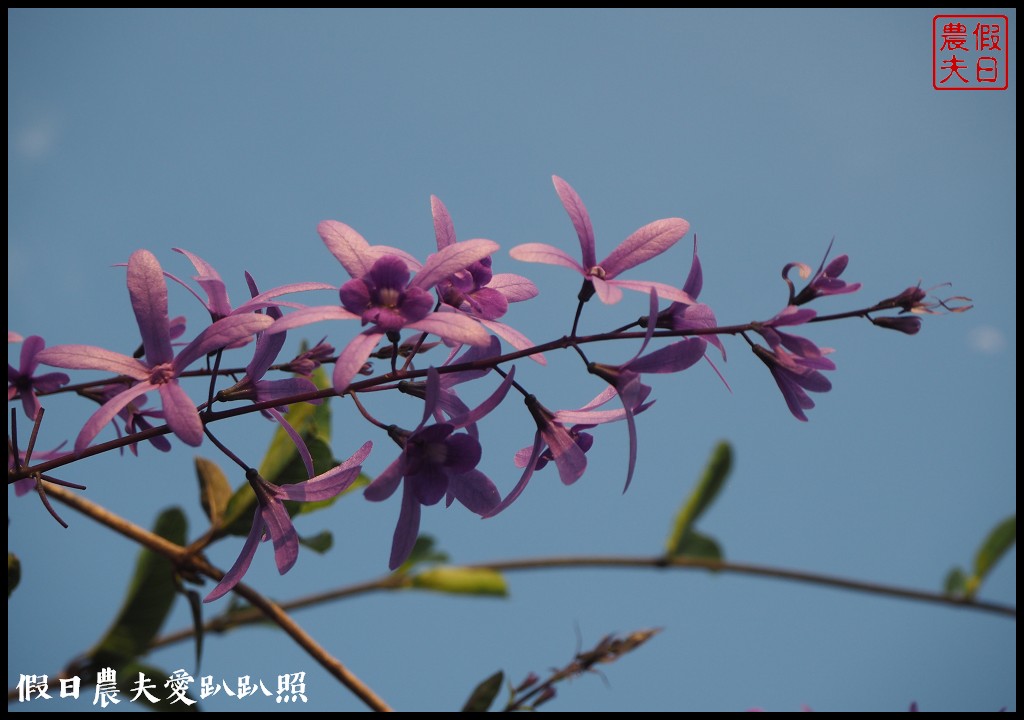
[510,180,692,303]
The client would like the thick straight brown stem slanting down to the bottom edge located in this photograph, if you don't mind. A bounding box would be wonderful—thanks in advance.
[37,488,391,711]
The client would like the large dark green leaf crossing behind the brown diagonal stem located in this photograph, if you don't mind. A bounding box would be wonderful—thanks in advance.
[91,508,187,667]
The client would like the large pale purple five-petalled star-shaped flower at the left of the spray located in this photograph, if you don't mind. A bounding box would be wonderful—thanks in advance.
[39,250,273,453]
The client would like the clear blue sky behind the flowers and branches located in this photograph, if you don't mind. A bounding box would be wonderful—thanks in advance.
[7,9,1017,711]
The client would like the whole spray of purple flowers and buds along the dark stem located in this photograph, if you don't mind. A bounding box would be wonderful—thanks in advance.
[7,177,950,601]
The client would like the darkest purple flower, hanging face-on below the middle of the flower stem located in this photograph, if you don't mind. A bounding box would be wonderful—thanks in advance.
[365,368,515,569]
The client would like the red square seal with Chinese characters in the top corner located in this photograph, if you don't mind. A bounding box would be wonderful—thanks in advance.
[932,15,1010,90]
